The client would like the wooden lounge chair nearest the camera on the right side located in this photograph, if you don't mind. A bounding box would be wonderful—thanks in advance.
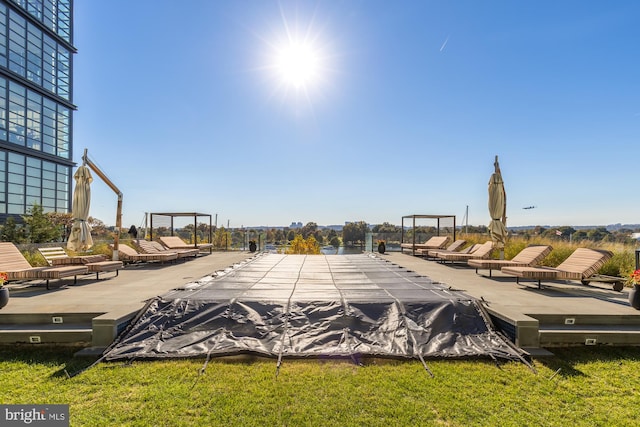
[500,248,613,288]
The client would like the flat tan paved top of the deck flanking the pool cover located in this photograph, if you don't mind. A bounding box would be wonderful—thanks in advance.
[0,252,640,315]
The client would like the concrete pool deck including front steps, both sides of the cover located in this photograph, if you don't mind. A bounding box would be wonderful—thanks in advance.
[0,251,640,355]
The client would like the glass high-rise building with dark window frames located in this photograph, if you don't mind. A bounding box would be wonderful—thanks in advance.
[0,0,76,224]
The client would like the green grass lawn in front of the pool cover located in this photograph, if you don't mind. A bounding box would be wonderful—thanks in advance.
[0,347,640,426]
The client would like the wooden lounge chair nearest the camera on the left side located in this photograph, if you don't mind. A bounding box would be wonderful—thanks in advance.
[0,242,89,289]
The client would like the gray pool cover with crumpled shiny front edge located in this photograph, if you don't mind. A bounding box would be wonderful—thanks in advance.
[103,254,521,361]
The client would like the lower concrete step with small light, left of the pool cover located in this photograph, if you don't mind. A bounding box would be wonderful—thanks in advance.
[0,324,93,344]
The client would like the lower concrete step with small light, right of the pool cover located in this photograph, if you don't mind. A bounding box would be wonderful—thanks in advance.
[539,324,640,347]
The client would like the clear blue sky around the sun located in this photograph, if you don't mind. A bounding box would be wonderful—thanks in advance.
[74,0,640,231]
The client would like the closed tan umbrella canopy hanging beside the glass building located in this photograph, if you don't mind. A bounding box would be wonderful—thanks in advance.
[67,164,93,252]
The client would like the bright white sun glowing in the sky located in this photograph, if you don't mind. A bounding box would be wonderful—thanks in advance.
[276,41,320,89]
